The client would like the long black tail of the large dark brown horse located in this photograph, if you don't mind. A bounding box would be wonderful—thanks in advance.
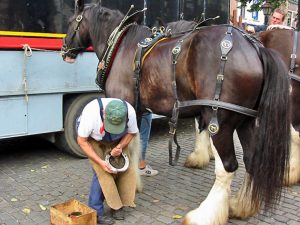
[250,48,290,210]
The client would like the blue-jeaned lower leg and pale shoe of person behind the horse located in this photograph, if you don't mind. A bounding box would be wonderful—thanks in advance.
[139,112,158,177]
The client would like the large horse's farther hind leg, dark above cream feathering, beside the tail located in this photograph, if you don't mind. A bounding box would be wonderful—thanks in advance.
[229,119,260,218]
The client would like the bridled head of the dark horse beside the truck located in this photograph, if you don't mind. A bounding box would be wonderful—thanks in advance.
[61,0,91,63]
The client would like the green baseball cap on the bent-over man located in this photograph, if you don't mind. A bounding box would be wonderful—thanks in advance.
[104,100,127,134]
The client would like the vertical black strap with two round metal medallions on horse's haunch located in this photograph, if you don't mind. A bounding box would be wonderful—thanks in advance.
[208,26,232,135]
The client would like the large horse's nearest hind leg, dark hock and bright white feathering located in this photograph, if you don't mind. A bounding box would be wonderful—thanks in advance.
[182,130,237,225]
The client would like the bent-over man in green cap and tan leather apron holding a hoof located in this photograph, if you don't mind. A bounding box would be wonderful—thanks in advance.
[77,98,140,224]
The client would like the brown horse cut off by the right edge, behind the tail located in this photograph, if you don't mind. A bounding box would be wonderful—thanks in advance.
[258,27,300,185]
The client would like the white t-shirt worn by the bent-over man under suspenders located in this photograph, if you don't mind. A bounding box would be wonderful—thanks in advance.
[78,98,139,141]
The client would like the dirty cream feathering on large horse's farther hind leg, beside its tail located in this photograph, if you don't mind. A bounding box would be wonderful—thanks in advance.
[229,173,260,219]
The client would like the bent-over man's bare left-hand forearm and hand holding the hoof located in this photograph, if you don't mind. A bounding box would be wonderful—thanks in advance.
[77,136,113,173]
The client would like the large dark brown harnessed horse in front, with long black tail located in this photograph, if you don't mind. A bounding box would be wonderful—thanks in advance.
[62,0,290,224]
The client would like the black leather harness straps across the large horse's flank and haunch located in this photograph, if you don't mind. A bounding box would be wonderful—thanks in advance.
[165,25,258,165]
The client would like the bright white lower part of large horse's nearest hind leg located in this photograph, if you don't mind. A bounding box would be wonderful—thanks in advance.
[182,136,234,225]
